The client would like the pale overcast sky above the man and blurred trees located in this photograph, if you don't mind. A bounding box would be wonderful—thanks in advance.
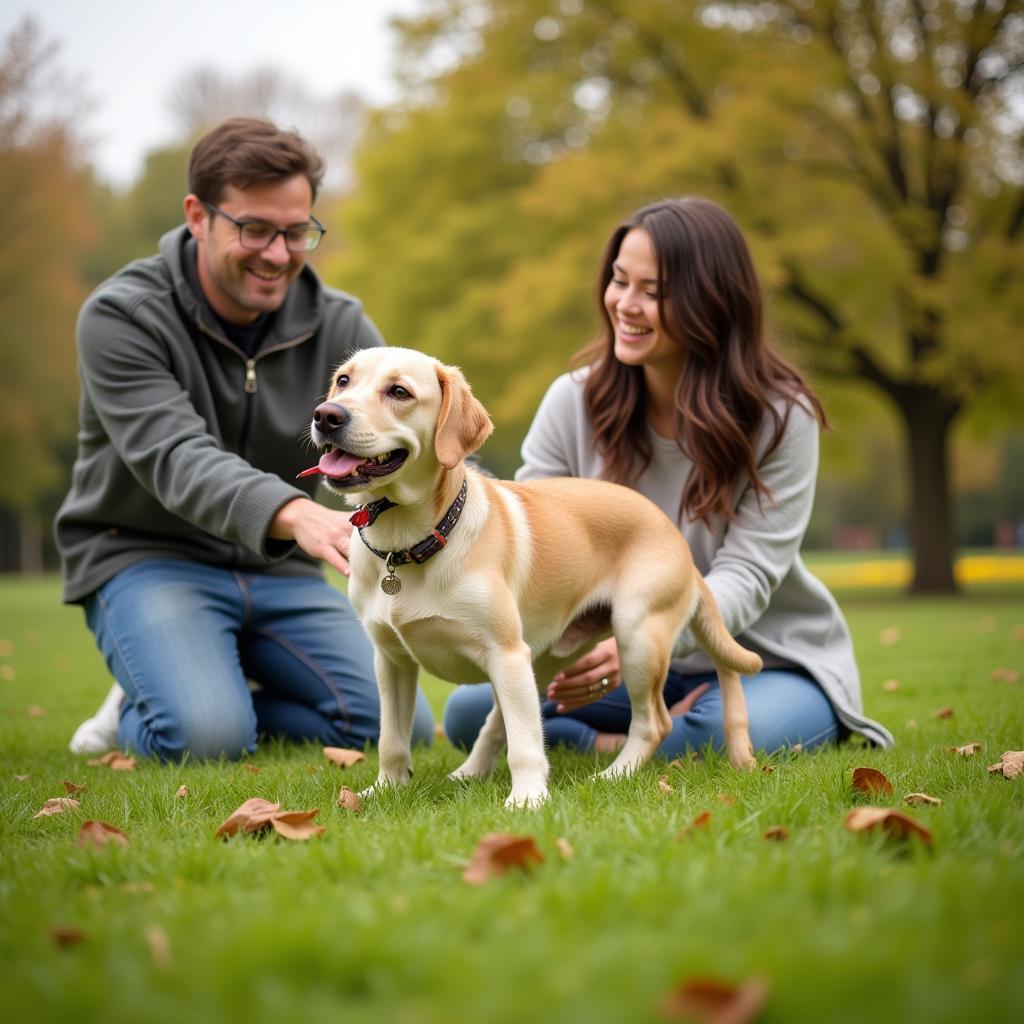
[0,0,423,184]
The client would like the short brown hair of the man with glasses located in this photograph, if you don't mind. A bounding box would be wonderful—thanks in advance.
[188,118,324,204]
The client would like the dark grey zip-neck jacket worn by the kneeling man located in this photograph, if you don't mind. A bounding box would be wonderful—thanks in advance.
[54,227,383,602]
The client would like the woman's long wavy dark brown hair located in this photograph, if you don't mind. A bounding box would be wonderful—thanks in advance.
[572,197,827,524]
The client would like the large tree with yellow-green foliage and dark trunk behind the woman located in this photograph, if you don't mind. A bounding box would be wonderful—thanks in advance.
[332,0,1024,592]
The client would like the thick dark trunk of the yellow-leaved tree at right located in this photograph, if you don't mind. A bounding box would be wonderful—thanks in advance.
[897,385,959,594]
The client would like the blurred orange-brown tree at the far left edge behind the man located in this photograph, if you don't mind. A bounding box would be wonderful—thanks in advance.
[0,20,94,567]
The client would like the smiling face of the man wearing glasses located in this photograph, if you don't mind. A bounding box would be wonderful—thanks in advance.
[185,174,312,324]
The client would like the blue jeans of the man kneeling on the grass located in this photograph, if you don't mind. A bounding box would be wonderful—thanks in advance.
[85,559,433,761]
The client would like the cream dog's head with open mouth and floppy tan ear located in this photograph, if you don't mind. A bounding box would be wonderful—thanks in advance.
[310,348,494,493]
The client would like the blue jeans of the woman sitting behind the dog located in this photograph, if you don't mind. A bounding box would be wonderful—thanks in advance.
[444,669,840,758]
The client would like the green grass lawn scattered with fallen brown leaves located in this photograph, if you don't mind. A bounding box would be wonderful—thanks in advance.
[0,580,1024,1024]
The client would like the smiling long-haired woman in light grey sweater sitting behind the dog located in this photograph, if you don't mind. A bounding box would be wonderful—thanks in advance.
[444,198,893,757]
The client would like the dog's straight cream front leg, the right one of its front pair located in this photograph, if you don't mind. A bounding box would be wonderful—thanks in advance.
[489,643,548,807]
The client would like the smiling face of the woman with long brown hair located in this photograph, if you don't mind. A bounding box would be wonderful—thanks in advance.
[604,227,683,383]
